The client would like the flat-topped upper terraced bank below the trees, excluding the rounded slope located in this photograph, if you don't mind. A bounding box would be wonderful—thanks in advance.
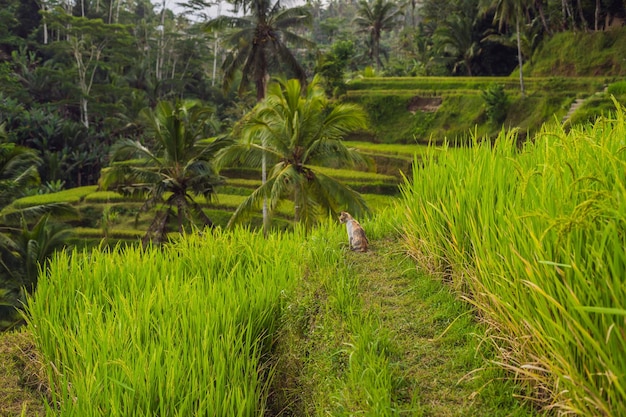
[344,76,615,143]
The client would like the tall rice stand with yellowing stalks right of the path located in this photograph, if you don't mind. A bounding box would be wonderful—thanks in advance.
[403,103,626,416]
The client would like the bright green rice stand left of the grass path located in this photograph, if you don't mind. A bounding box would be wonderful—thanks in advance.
[28,229,304,416]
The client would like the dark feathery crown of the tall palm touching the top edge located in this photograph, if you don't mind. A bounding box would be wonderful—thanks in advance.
[207,0,315,101]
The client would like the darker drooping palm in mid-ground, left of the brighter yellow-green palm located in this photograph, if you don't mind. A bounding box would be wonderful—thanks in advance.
[102,100,230,245]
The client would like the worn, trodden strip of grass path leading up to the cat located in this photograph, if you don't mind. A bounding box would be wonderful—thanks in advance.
[350,239,533,417]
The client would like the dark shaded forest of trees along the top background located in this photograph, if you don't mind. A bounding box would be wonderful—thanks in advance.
[0,0,625,192]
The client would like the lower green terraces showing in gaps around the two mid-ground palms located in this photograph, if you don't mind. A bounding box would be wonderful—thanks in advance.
[8,164,400,246]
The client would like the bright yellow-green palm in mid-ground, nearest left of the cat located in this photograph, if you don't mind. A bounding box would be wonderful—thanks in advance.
[223,77,369,227]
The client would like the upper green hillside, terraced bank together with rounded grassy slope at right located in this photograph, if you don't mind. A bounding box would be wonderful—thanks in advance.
[343,29,626,144]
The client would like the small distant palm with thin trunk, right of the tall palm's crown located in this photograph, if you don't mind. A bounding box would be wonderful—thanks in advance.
[354,0,401,71]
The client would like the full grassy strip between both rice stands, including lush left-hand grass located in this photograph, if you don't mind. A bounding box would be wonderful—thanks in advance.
[271,238,534,417]
